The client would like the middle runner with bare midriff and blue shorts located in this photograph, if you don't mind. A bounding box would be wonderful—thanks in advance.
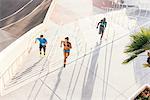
[60,37,72,68]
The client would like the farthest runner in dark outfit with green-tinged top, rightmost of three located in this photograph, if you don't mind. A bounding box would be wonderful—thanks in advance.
[97,18,107,40]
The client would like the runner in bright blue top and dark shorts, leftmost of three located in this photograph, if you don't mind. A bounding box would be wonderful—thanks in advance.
[35,35,47,55]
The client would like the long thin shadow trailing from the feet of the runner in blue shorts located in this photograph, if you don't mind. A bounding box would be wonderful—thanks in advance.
[49,67,64,100]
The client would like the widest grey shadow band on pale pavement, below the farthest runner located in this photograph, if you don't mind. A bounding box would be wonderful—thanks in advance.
[81,42,100,100]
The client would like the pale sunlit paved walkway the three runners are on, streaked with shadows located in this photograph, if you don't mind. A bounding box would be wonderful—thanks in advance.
[0,12,144,100]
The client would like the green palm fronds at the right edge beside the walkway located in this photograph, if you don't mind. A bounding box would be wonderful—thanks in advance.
[123,28,150,64]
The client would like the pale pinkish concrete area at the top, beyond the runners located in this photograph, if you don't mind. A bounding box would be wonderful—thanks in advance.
[49,0,93,24]
